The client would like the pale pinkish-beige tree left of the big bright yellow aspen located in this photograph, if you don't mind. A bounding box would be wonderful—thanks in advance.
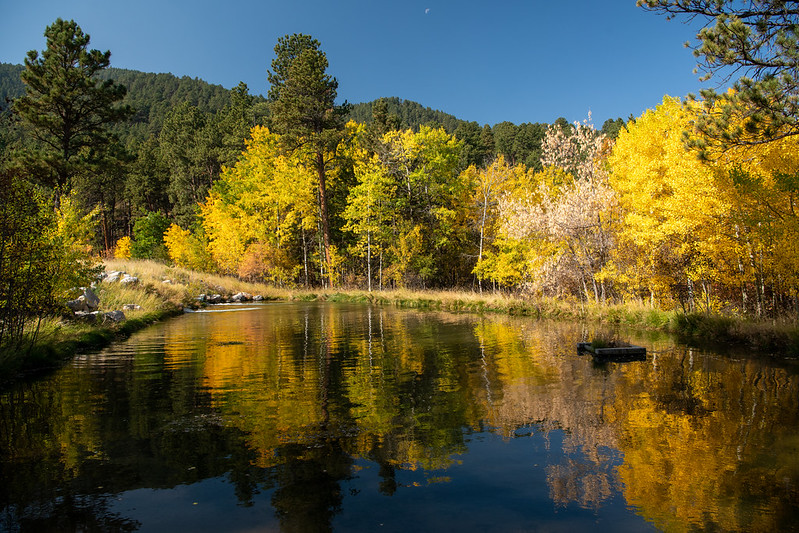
[500,116,615,301]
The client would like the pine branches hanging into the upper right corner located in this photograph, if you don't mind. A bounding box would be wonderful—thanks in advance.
[638,0,799,151]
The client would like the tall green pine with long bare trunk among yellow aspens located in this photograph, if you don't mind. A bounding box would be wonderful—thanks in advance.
[268,34,348,284]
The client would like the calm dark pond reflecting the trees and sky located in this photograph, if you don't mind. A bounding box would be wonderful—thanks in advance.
[0,303,799,532]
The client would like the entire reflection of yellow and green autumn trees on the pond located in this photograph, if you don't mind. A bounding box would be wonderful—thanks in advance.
[155,304,799,531]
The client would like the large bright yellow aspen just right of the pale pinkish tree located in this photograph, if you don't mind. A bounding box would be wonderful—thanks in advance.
[609,96,737,308]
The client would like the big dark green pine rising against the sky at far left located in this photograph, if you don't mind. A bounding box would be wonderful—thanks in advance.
[14,18,131,203]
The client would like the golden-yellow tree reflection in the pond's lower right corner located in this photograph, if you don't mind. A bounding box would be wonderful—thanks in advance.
[616,353,799,531]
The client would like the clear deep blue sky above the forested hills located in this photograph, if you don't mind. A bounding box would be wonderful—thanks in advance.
[0,0,702,126]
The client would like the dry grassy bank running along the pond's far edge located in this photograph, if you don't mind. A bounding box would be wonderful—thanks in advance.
[0,260,799,379]
